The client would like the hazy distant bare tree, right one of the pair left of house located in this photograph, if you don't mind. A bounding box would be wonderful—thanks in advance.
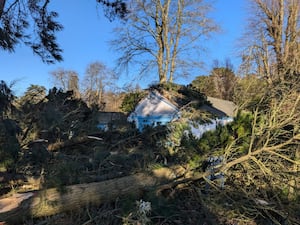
[83,62,116,108]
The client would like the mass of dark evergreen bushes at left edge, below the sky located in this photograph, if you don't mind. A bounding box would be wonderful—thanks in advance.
[0,81,96,170]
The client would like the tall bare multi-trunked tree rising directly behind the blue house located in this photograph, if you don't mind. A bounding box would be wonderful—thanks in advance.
[112,0,217,83]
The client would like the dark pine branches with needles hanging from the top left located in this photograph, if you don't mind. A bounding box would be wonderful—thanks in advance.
[0,0,127,63]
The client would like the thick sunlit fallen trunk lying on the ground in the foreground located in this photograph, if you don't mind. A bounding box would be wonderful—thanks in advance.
[0,167,190,223]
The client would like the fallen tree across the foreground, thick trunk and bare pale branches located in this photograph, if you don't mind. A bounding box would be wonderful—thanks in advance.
[0,97,300,223]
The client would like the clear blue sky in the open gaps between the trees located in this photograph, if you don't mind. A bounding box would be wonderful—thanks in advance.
[0,0,247,95]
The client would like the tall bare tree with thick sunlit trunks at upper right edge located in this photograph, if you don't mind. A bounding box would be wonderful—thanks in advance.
[244,0,300,84]
